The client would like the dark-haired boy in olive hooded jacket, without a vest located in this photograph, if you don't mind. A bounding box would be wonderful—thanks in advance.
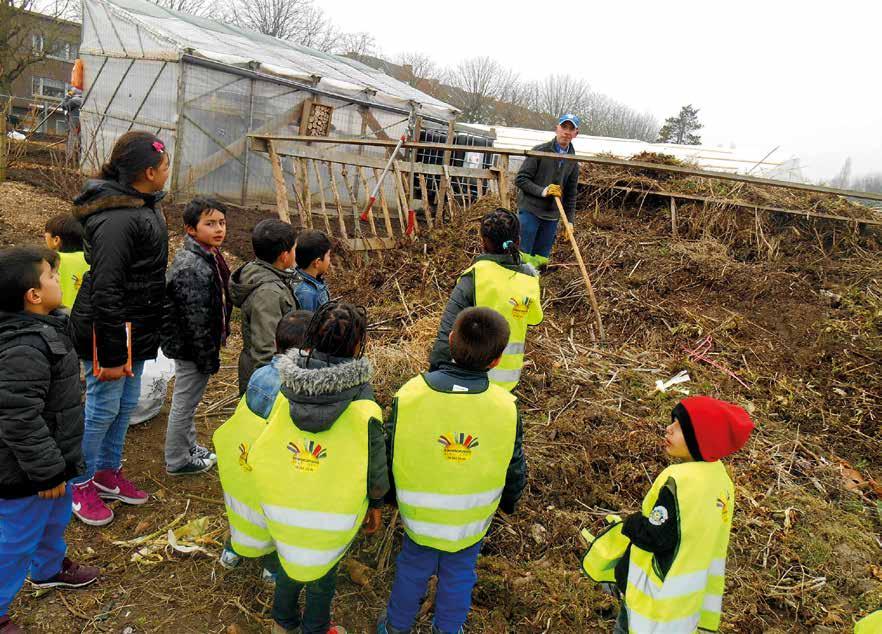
[230,218,297,396]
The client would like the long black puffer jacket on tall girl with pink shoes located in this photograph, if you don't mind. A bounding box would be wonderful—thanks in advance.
[71,180,168,368]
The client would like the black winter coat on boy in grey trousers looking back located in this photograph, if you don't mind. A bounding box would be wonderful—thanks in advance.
[162,236,233,374]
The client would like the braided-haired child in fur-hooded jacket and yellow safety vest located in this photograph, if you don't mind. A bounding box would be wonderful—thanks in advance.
[248,302,389,634]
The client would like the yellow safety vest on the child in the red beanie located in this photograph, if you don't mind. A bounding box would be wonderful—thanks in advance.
[625,461,735,634]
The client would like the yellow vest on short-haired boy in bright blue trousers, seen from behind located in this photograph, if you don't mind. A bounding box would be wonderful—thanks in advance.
[392,376,518,552]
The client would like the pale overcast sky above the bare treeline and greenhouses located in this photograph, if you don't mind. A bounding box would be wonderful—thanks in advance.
[317,0,882,179]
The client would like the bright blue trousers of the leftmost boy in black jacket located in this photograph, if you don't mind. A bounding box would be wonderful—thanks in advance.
[0,486,71,616]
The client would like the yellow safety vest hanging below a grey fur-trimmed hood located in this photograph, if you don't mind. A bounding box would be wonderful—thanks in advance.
[249,394,383,582]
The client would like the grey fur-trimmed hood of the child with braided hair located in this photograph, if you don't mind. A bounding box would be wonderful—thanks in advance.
[275,350,374,433]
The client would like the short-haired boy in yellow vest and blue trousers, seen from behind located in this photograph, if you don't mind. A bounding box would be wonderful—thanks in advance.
[377,308,527,634]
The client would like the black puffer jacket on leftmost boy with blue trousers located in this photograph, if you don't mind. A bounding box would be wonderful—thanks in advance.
[0,312,83,499]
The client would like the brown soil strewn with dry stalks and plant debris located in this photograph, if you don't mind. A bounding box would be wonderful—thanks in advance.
[0,154,882,634]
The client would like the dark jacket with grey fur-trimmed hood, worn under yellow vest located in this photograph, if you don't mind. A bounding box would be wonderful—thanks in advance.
[275,350,389,508]
